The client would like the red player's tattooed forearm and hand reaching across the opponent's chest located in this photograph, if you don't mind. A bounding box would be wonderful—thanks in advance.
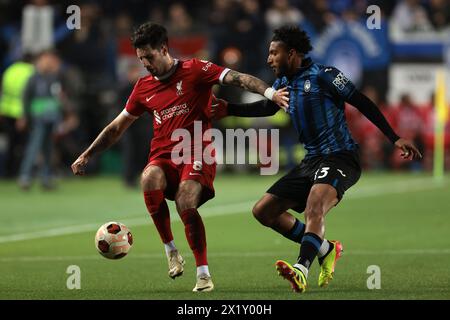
[223,70,289,109]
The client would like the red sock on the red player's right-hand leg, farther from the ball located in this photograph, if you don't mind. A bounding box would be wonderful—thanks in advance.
[180,208,208,267]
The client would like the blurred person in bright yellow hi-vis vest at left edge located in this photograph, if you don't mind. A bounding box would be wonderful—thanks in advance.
[0,55,34,178]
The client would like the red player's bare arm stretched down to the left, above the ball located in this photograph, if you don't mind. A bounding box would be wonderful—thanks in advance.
[71,113,135,175]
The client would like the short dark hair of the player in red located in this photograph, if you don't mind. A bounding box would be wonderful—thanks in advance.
[131,22,169,49]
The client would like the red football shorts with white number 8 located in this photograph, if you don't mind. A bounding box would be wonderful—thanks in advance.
[144,154,216,207]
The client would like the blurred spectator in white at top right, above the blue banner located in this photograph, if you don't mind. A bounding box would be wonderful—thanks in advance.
[391,0,432,32]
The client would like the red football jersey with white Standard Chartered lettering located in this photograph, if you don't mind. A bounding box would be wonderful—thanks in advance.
[123,59,229,160]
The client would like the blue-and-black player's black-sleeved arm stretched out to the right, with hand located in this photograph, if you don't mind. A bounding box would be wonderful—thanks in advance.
[346,90,422,160]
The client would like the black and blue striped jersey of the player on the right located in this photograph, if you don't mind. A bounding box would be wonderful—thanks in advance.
[272,58,358,158]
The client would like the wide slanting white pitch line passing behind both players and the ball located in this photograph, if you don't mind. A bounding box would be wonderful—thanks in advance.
[0,178,446,243]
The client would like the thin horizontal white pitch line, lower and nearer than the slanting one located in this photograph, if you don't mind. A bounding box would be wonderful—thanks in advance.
[0,249,450,263]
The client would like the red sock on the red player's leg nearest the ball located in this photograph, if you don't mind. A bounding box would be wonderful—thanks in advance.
[144,190,173,243]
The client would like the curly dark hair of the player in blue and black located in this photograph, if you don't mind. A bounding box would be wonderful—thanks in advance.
[272,25,313,54]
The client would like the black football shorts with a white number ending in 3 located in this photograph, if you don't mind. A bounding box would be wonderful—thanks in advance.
[267,150,361,212]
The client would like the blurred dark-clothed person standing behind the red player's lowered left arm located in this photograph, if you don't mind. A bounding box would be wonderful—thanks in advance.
[58,2,117,168]
